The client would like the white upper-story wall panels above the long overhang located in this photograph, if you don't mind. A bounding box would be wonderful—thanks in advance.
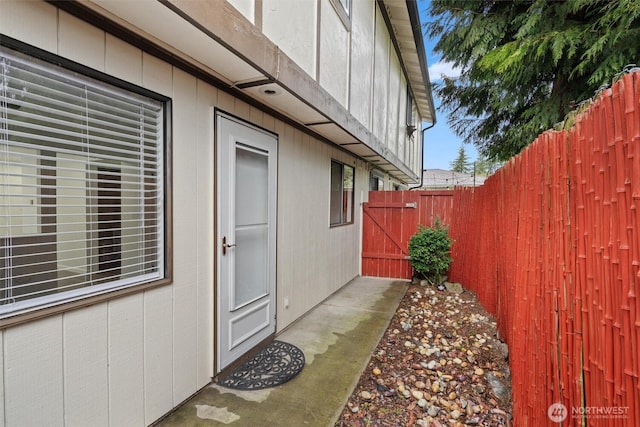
[229,0,421,176]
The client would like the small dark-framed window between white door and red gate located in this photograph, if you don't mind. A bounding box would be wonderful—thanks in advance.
[329,160,355,226]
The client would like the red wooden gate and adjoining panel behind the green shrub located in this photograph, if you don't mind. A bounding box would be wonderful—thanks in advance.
[362,190,453,279]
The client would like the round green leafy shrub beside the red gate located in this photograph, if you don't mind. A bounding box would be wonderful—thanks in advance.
[409,219,453,284]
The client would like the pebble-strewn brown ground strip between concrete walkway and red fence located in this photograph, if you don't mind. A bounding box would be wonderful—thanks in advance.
[335,284,511,427]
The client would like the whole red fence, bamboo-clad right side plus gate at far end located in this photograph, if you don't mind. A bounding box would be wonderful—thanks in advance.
[363,72,640,426]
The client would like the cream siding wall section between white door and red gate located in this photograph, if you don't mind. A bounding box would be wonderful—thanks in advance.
[277,133,368,330]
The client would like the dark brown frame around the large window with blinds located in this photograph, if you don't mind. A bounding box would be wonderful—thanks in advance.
[0,34,173,329]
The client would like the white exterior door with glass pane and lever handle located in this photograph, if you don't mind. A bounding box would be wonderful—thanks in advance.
[216,113,278,372]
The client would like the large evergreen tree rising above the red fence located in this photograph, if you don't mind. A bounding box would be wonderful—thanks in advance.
[426,0,640,160]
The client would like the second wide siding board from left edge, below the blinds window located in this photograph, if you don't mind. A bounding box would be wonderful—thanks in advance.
[63,304,109,427]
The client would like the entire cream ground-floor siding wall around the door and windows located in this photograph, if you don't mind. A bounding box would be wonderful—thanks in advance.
[0,1,369,426]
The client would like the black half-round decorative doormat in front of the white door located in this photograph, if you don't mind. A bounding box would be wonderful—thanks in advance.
[218,341,304,390]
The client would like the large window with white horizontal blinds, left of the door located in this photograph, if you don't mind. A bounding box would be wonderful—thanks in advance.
[0,46,166,318]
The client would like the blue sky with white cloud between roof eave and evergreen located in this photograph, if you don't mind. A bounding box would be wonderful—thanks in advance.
[418,0,478,169]
